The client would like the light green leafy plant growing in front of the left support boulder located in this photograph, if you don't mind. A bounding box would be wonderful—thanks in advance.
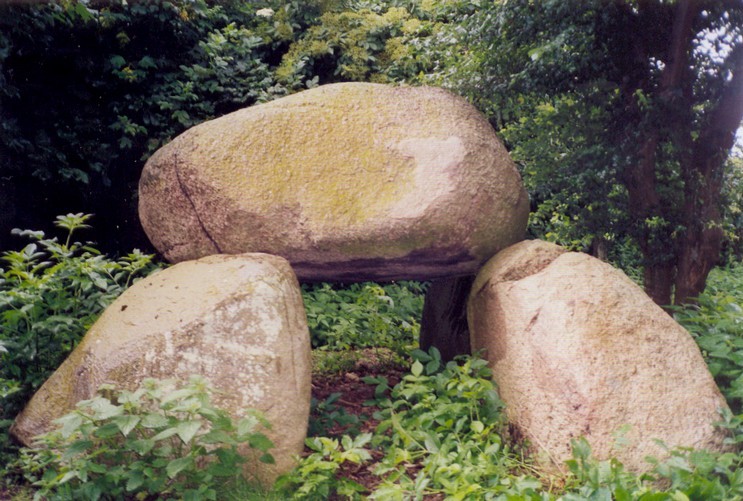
[20,376,273,500]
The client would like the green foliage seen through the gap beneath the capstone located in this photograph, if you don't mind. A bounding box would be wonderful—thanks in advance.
[302,282,425,353]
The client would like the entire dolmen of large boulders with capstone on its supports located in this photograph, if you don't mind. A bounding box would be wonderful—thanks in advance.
[12,83,726,481]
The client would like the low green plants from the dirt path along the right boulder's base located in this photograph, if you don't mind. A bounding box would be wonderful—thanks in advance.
[276,342,743,501]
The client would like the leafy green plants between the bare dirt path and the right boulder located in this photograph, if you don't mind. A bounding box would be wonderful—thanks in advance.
[371,348,541,499]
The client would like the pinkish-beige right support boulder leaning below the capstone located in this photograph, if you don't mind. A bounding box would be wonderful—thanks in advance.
[468,241,727,471]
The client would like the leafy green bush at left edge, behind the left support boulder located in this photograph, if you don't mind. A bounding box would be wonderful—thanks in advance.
[0,214,155,460]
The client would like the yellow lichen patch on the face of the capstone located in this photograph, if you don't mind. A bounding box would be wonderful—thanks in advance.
[176,85,454,233]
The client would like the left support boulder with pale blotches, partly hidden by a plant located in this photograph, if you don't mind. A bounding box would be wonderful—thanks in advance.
[12,254,311,480]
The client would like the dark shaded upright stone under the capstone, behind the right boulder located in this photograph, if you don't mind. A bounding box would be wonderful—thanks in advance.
[420,276,475,361]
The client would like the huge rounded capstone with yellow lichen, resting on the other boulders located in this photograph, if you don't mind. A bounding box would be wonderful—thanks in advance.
[139,83,529,280]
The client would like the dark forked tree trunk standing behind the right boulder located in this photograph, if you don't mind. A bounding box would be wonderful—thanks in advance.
[625,0,743,306]
